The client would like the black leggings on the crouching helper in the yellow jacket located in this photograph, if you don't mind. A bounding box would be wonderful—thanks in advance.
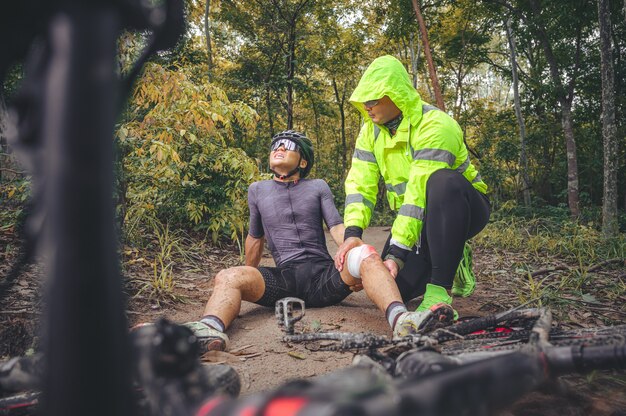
[383,169,491,302]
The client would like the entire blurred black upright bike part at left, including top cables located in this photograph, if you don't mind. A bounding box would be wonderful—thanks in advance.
[0,0,182,416]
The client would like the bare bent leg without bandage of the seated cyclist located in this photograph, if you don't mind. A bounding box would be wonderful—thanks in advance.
[203,266,265,328]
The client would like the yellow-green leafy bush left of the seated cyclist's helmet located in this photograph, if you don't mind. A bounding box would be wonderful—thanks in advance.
[117,64,259,242]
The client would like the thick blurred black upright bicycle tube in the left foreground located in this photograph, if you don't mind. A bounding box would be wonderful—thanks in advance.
[42,10,132,416]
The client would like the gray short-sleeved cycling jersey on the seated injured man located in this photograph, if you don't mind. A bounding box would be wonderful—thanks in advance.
[248,179,343,266]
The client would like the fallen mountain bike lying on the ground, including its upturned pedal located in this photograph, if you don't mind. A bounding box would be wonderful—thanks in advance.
[184,300,626,416]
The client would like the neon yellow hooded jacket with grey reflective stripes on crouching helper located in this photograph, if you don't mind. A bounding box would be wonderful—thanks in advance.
[344,55,487,249]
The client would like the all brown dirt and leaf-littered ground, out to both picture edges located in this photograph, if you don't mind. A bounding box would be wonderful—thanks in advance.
[0,227,626,416]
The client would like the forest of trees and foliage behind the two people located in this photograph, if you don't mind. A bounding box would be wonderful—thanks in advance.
[0,0,626,306]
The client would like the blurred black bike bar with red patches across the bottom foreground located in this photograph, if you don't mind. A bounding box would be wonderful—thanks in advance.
[194,346,626,416]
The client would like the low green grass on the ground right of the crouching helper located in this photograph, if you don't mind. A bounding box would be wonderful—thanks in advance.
[472,206,626,324]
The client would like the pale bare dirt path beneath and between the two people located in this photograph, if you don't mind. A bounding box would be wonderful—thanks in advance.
[141,227,482,394]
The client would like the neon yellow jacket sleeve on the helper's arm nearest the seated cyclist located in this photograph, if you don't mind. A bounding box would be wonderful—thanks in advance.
[344,123,380,230]
